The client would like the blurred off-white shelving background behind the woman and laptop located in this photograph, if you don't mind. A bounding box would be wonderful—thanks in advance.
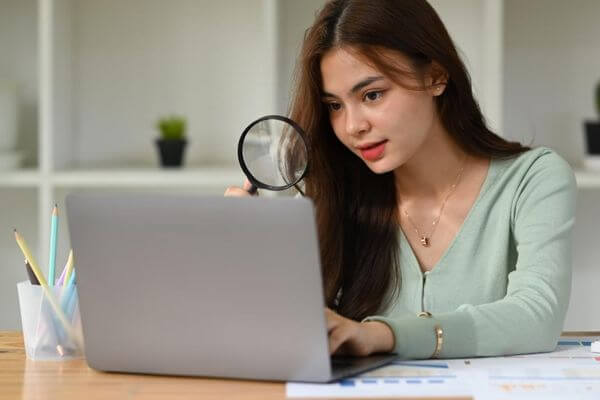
[0,0,600,331]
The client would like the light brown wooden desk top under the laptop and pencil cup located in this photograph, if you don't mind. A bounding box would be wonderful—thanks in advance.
[0,331,597,400]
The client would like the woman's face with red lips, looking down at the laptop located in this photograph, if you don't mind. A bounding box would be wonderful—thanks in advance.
[321,48,443,173]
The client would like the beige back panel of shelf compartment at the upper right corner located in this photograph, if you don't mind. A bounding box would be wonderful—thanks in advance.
[504,0,600,165]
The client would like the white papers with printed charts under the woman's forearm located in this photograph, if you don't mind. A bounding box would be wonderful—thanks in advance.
[287,337,600,400]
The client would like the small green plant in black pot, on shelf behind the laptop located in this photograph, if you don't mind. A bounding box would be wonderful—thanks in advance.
[156,115,187,167]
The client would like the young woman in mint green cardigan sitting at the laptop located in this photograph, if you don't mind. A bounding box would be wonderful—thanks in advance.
[226,0,576,358]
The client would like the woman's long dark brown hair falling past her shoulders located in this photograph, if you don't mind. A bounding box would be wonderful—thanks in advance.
[290,0,528,320]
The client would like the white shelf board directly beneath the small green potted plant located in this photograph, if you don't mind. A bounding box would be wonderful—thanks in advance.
[51,167,244,187]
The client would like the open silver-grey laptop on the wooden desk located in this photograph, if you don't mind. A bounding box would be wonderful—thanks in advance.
[66,193,395,382]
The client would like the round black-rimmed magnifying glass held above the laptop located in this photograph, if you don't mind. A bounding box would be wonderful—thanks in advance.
[238,115,308,194]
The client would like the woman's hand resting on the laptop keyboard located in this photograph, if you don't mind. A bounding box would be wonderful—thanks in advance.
[325,308,394,356]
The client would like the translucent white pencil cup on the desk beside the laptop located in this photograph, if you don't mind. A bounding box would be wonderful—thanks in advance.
[17,281,83,361]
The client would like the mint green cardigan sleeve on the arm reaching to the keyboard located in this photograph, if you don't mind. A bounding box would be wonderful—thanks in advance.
[367,152,577,358]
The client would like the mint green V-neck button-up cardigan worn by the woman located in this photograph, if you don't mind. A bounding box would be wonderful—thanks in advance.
[365,147,577,359]
